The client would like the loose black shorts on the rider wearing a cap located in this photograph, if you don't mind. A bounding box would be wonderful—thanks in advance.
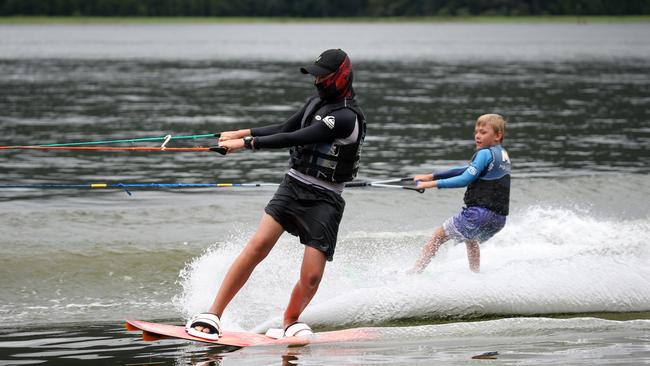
[264,175,345,261]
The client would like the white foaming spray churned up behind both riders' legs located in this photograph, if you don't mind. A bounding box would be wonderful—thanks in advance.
[178,207,650,329]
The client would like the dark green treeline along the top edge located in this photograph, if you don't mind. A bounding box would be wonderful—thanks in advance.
[0,0,650,17]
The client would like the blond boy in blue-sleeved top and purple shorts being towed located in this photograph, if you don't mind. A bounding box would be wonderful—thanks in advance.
[409,114,510,273]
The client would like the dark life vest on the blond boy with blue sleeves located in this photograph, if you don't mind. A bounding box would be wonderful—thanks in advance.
[464,145,511,216]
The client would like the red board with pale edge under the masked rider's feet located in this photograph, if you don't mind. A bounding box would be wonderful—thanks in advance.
[126,319,376,347]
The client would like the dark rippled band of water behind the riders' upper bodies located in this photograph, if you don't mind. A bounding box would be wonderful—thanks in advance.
[0,60,650,181]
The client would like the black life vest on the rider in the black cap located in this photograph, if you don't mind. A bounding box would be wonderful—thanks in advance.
[291,96,366,183]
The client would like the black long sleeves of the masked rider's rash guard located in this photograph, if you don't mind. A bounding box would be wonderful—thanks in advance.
[251,101,357,149]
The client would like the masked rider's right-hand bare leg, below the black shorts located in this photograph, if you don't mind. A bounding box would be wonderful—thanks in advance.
[283,246,326,329]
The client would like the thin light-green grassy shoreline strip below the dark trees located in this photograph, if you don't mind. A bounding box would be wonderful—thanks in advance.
[0,15,650,24]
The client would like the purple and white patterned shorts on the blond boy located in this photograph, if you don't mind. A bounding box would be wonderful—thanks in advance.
[442,207,506,242]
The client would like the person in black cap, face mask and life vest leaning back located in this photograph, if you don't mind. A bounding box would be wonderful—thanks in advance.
[186,49,366,340]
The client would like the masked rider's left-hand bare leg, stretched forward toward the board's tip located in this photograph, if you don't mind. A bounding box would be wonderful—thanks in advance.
[196,214,284,332]
